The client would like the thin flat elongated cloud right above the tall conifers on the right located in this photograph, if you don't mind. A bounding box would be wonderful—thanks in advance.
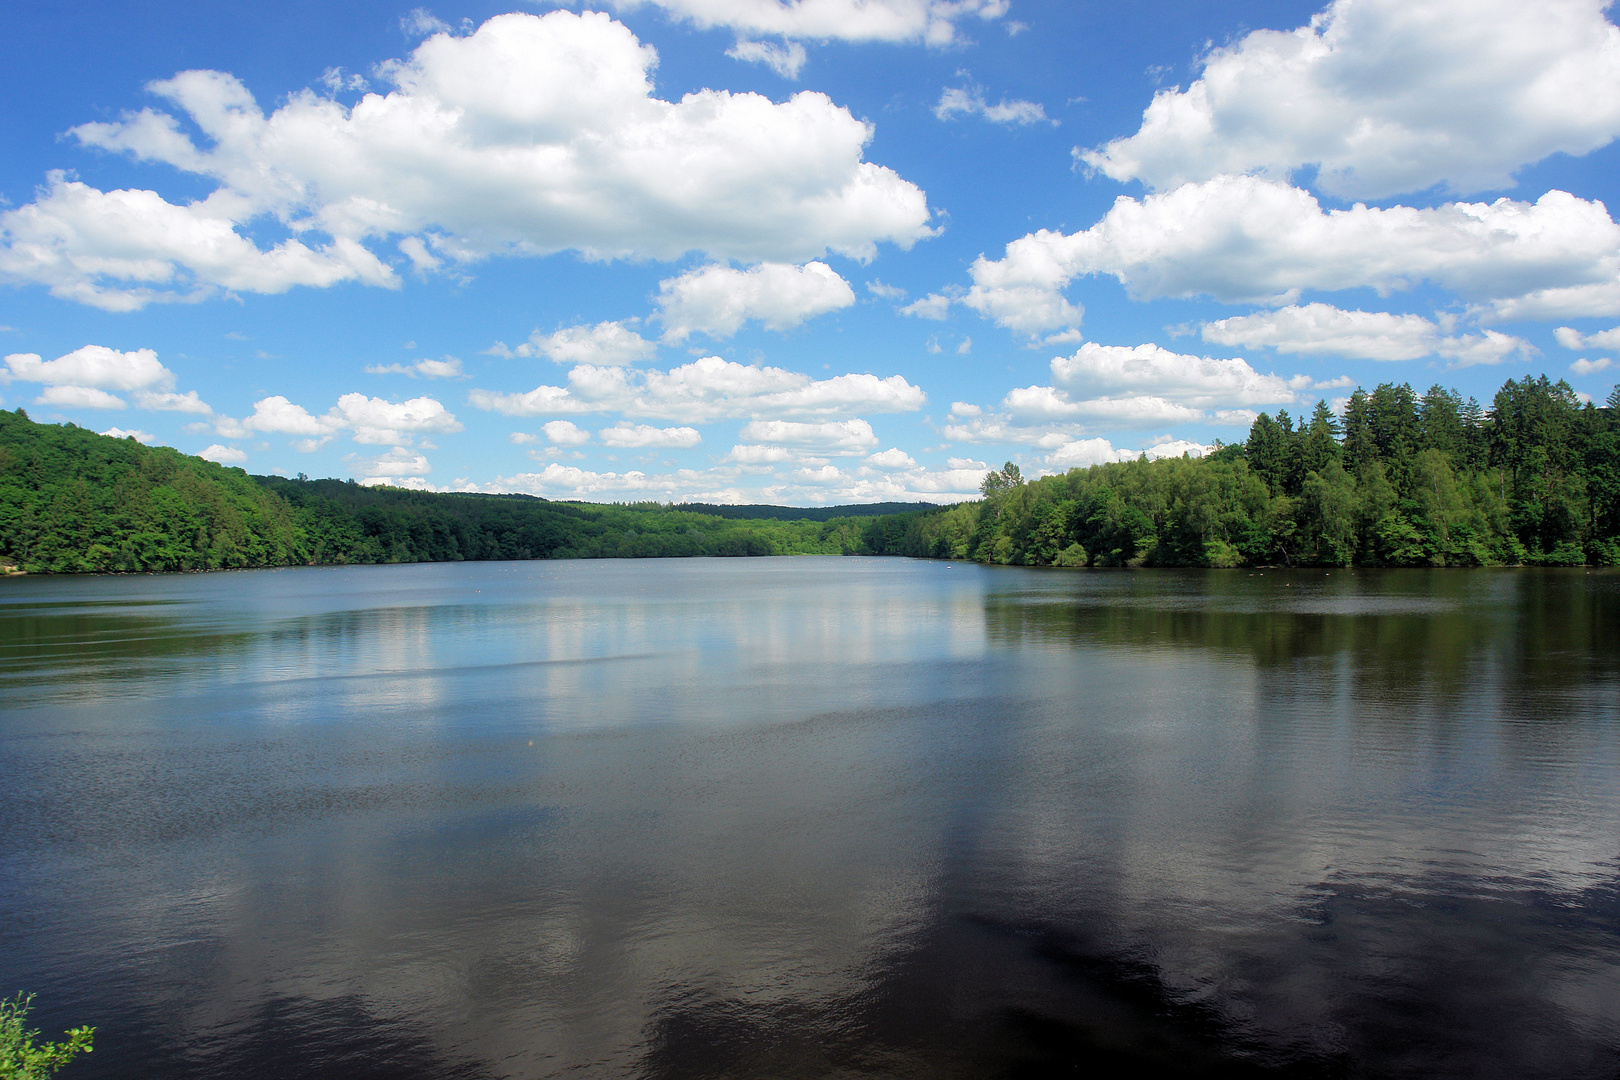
[1202,303,1536,366]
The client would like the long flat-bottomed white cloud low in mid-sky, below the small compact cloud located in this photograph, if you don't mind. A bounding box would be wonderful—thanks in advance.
[468,356,927,424]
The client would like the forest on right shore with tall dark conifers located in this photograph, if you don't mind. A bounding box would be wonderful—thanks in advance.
[862,376,1620,567]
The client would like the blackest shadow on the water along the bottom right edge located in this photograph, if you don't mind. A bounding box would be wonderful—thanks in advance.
[638,882,1620,1080]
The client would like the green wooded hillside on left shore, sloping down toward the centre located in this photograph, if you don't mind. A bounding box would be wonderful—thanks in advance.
[0,410,887,573]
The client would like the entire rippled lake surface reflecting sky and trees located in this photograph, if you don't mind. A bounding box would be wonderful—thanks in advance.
[0,559,1620,1080]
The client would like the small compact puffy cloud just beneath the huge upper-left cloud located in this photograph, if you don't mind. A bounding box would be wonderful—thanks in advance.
[658,262,855,342]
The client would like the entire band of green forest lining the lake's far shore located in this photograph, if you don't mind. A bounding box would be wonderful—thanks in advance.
[0,376,1620,573]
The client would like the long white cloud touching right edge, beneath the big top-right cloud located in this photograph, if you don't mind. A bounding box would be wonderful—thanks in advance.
[964,176,1620,332]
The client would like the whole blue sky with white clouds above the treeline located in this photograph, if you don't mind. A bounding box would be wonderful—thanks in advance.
[0,0,1620,505]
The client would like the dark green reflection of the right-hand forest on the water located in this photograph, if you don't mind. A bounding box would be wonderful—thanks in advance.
[985,570,1620,716]
